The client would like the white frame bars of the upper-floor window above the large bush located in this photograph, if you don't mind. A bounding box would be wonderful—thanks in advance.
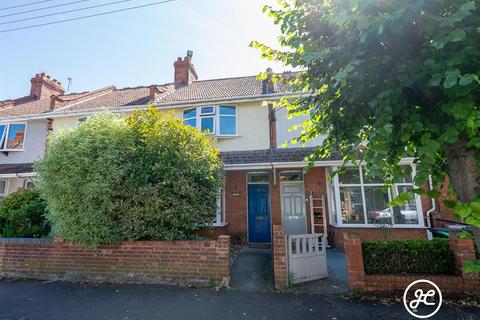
[182,105,238,137]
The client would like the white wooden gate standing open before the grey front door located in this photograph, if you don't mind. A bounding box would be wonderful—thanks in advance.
[287,233,327,283]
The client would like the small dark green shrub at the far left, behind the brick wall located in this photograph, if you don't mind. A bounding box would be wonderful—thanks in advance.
[0,189,50,238]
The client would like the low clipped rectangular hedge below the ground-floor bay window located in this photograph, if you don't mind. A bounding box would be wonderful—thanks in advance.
[362,238,453,274]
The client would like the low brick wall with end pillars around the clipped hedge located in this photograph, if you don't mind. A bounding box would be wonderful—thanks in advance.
[344,234,480,295]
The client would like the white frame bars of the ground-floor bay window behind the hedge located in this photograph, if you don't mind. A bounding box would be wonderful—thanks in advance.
[326,165,425,229]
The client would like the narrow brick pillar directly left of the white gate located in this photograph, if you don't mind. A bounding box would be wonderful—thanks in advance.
[272,225,288,290]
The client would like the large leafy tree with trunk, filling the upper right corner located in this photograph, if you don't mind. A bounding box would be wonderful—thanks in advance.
[252,0,480,227]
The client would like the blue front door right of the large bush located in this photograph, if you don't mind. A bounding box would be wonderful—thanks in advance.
[248,184,271,242]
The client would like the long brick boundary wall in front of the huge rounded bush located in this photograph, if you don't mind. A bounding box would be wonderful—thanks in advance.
[0,235,230,286]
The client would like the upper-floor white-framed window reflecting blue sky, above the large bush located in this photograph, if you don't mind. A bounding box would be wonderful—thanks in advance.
[183,106,237,136]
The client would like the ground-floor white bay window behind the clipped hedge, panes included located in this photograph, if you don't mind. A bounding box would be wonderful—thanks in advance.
[328,166,424,227]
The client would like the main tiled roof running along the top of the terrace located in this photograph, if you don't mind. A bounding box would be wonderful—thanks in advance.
[0,76,290,118]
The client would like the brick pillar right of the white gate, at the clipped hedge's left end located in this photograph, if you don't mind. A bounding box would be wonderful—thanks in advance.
[343,233,365,289]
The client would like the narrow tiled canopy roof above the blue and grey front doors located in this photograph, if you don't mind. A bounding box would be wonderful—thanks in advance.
[220,147,341,164]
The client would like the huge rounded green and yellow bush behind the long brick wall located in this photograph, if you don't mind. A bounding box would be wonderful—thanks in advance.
[36,107,222,246]
